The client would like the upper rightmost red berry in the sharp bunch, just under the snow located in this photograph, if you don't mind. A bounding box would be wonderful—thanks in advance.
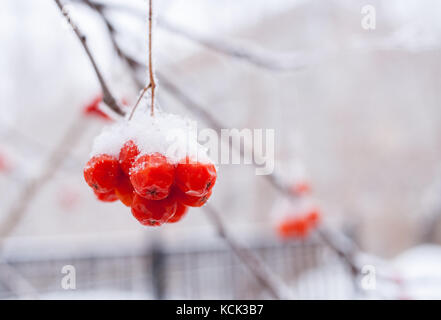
[176,158,216,197]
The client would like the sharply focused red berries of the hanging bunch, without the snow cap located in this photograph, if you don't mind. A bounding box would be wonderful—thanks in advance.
[84,140,217,226]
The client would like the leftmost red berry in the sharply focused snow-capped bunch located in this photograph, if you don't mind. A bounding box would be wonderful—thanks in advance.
[84,154,121,193]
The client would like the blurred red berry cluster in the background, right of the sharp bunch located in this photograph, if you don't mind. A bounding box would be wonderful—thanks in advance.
[277,209,320,239]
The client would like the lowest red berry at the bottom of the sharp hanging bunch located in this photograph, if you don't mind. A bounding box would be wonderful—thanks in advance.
[132,194,178,226]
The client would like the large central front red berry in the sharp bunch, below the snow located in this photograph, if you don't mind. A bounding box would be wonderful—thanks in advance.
[130,153,175,200]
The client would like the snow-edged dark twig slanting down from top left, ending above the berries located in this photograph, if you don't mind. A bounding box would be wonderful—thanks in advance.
[54,0,124,116]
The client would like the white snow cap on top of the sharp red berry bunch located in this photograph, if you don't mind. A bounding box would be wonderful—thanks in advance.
[90,109,212,164]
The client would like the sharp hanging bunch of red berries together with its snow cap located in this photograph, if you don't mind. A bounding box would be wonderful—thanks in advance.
[84,112,217,226]
